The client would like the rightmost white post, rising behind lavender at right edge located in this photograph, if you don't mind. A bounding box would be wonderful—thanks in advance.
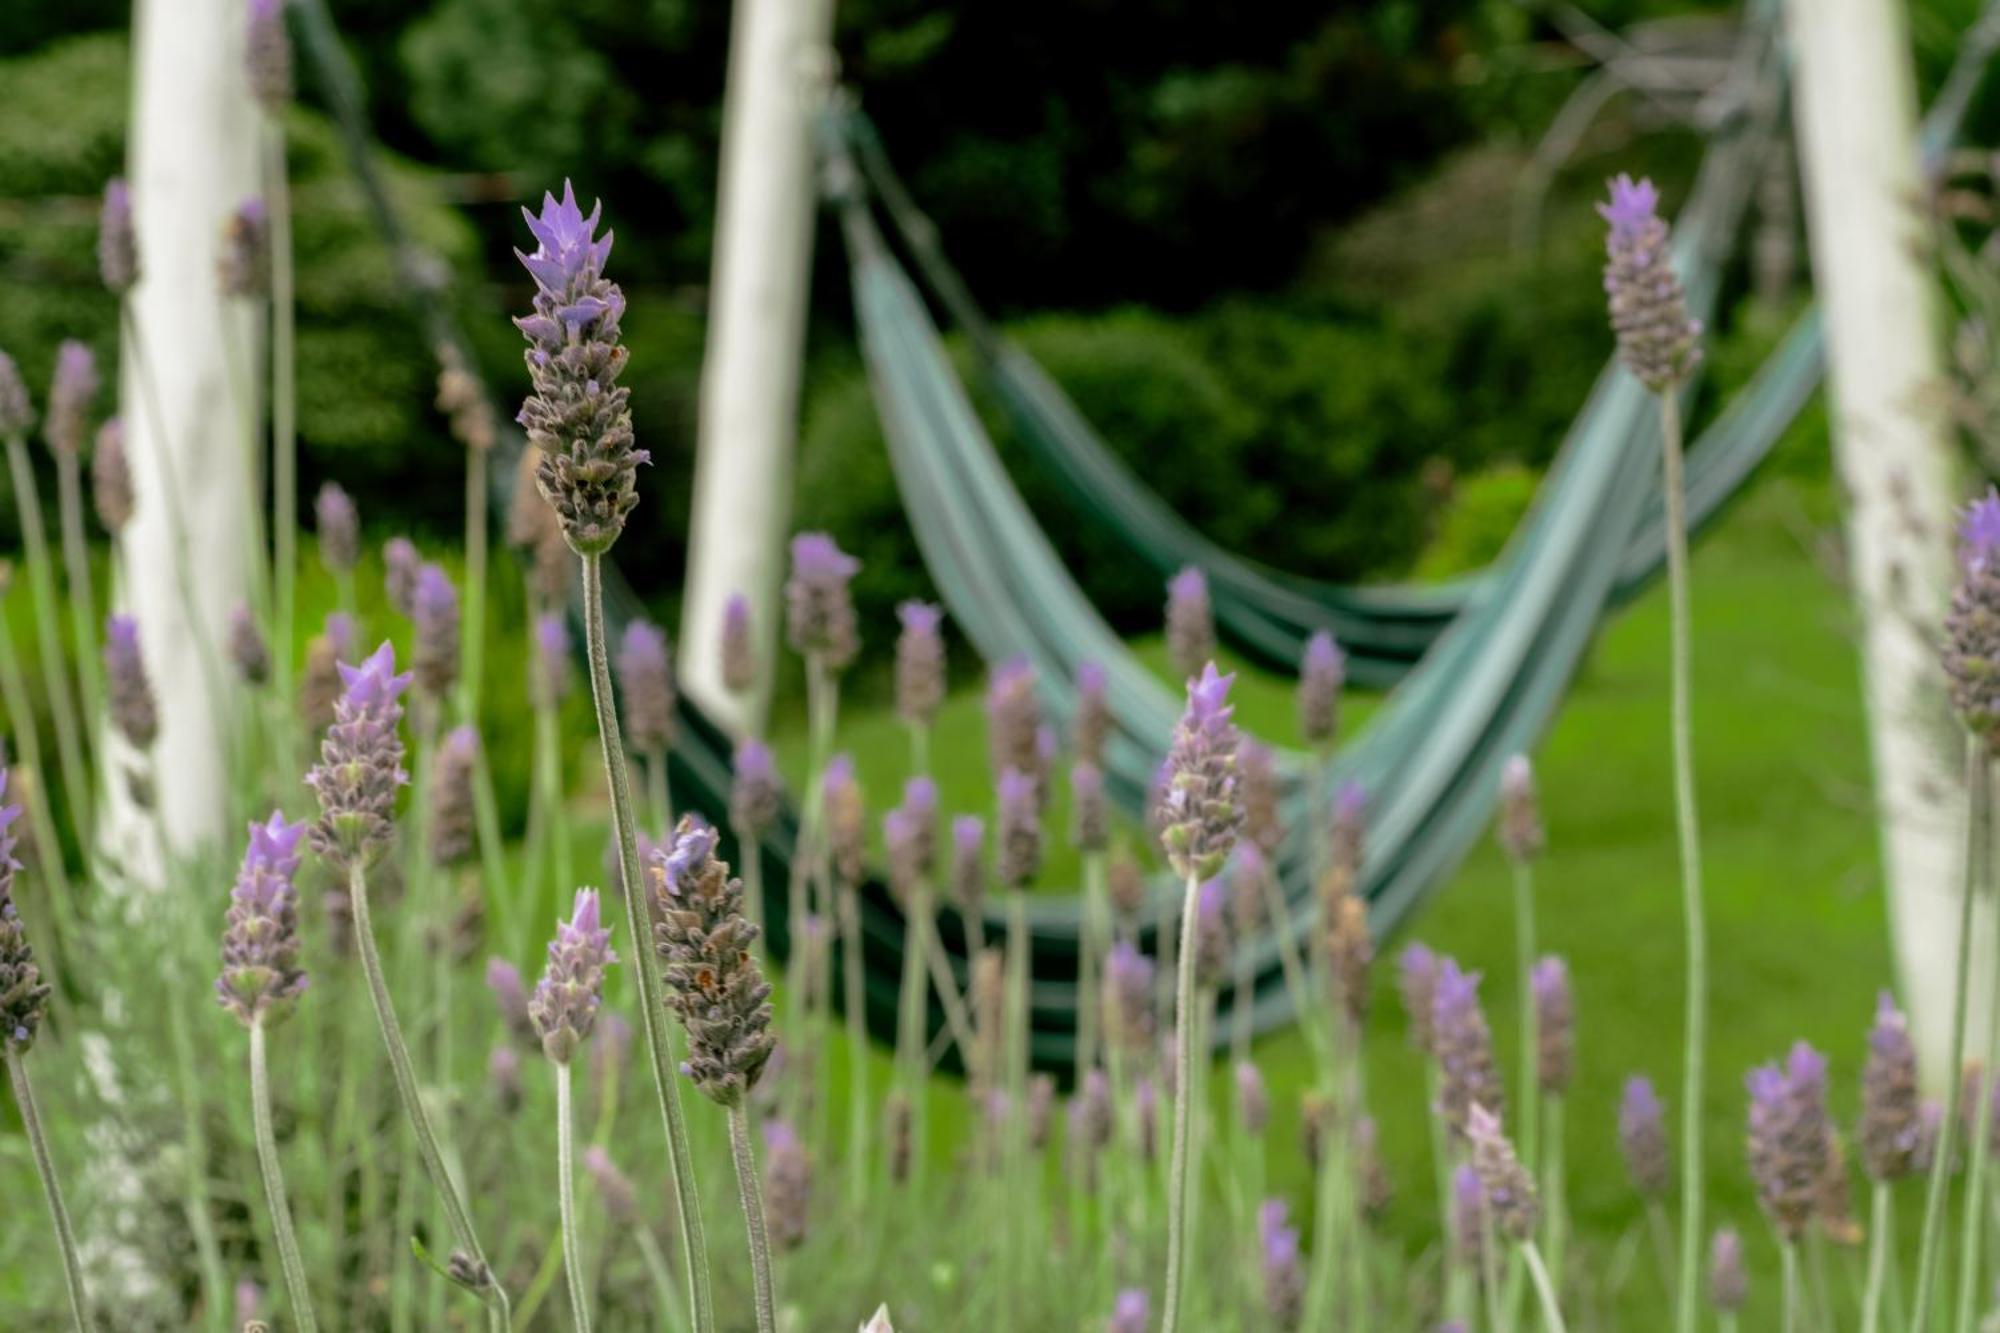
[1786,0,1960,1081]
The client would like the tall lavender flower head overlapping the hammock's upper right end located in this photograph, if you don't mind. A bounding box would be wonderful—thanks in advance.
[1598,174,1702,394]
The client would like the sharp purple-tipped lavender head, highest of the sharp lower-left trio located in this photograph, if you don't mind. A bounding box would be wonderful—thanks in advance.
[306,640,410,867]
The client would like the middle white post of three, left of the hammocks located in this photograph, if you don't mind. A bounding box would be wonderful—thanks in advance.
[680,0,834,731]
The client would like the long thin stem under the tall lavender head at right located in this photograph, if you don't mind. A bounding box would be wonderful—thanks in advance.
[1656,390,1708,1333]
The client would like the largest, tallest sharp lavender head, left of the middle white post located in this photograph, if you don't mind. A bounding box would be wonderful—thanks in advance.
[514,180,648,554]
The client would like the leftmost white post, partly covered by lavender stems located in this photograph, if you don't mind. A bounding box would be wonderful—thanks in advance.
[102,0,258,883]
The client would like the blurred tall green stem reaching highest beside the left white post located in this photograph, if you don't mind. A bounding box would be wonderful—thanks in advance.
[264,114,298,699]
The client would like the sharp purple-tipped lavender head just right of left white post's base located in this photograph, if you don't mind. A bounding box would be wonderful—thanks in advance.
[216,811,306,1027]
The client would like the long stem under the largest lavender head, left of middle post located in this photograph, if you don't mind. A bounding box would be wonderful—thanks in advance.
[582,554,718,1333]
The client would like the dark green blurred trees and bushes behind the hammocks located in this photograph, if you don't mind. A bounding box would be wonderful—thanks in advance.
[0,0,2000,628]
